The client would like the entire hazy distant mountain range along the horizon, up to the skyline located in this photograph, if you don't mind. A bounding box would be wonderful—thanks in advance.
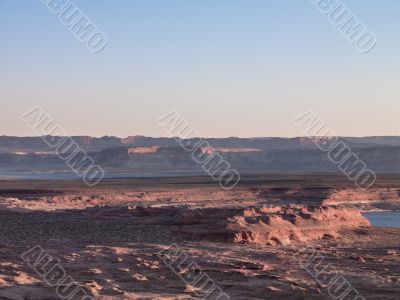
[0,136,400,178]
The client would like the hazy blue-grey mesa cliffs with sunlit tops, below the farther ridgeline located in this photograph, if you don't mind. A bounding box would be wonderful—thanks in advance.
[0,147,400,176]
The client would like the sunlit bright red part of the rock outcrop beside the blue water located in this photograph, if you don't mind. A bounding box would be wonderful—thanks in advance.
[227,206,370,245]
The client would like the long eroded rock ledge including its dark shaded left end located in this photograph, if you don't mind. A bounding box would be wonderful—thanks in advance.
[82,205,370,245]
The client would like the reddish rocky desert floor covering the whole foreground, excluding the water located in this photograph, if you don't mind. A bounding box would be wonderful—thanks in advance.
[0,174,400,300]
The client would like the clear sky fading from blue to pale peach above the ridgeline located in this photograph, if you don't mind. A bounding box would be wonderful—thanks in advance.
[0,0,400,137]
